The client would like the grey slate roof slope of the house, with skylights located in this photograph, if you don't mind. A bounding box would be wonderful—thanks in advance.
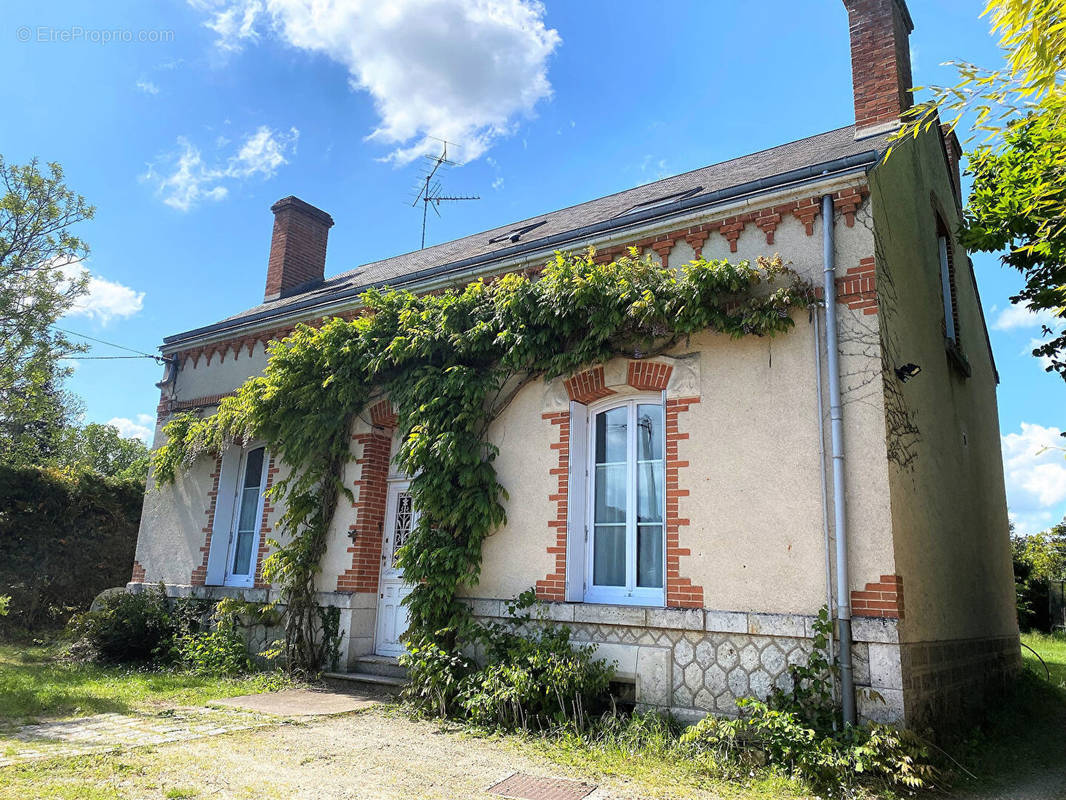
[164,125,887,343]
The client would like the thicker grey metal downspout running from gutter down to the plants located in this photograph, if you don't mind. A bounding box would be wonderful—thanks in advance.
[822,194,855,725]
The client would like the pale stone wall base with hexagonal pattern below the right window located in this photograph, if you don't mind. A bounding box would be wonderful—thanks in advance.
[470,599,904,722]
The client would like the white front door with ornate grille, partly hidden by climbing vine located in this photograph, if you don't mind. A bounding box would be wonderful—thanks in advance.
[374,481,418,656]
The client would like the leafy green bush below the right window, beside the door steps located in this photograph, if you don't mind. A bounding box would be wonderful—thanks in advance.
[402,590,613,731]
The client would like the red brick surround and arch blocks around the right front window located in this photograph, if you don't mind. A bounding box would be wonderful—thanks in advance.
[536,362,704,608]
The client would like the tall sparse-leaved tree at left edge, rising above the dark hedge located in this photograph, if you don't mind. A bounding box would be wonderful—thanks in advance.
[0,157,94,463]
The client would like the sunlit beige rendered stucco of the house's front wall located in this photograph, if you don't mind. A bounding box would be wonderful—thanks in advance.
[131,180,894,625]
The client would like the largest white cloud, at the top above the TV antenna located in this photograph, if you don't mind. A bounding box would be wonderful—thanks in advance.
[189,0,561,163]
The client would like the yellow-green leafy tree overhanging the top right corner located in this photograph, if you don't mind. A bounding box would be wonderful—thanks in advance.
[897,0,1066,380]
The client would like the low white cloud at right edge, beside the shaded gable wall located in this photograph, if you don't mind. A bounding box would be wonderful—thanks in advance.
[1002,422,1066,533]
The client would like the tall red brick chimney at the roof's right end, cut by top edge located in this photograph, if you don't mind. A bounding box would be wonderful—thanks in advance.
[844,0,915,139]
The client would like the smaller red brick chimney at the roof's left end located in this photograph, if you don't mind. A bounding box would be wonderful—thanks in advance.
[263,196,333,300]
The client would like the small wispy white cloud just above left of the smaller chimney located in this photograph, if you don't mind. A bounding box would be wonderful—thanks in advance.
[142,125,300,211]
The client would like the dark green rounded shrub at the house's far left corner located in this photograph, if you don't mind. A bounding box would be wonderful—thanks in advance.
[69,587,176,665]
